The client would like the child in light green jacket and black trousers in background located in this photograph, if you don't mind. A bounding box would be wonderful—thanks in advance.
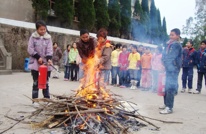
[69,42,79,81]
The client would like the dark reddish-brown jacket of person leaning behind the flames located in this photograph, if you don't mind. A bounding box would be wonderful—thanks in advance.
[77,37,97,62]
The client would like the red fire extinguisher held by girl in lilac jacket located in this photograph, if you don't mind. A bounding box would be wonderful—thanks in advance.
[38,64,48,89]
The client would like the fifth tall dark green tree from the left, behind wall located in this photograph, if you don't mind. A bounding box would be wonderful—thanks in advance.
[108,0,121,36]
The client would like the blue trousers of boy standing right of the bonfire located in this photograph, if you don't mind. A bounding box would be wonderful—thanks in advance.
[164,71,179,109]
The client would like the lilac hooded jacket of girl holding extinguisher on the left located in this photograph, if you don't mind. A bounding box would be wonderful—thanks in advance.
[27,32,53,71]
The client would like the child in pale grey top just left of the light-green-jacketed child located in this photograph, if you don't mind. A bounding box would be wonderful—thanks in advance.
[63,44,71,81]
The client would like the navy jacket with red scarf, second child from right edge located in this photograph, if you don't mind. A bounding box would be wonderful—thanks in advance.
[182,48,197,68]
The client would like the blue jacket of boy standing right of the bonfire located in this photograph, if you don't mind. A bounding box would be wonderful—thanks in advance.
[162,41,182,72]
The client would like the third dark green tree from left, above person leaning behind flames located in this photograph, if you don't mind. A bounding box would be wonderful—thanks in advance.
[78,0,96,31]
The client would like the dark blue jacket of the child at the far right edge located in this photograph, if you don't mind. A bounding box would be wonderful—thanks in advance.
[197,49,206,73]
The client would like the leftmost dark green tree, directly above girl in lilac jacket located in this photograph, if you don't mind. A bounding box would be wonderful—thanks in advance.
[31,0,49,20]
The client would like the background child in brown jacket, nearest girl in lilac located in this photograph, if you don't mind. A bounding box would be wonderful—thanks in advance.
[52,42,62,79]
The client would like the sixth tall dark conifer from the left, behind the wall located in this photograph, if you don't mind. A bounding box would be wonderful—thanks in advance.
[120,0,132,39]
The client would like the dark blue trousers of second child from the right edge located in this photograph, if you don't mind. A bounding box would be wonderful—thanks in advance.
[182,67,193,89]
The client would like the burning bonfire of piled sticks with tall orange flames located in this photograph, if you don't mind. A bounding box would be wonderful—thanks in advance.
[1,43,181,134]
